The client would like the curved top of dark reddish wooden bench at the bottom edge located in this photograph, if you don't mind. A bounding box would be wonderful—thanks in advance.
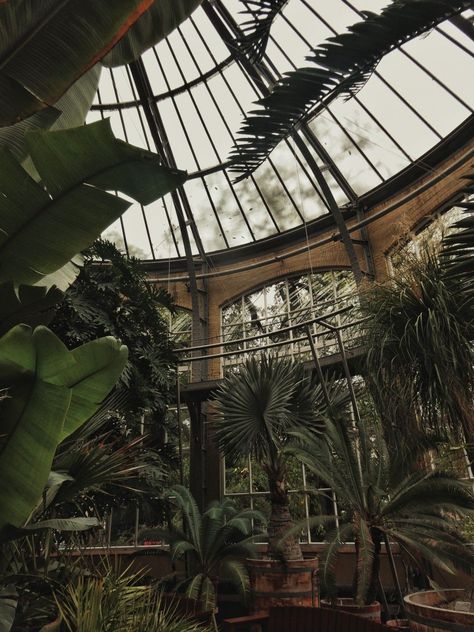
[224,606,389,632]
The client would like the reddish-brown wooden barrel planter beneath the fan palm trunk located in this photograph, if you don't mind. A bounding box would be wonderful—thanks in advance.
[246,558,319,612]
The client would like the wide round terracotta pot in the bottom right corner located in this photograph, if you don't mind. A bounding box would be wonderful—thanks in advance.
[405,589,474,632]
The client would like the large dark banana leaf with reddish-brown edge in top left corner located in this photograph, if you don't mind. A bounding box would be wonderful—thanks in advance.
[0,0,153,126]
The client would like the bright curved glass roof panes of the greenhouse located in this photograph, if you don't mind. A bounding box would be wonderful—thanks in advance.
[89,0,474,260]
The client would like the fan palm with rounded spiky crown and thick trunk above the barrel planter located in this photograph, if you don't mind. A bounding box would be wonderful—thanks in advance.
[214,356,346,560]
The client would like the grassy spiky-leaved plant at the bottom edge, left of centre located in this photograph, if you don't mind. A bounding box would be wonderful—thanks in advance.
[56,560,209,632]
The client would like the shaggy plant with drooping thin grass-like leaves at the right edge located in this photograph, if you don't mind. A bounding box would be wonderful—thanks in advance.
[363,185,474,446]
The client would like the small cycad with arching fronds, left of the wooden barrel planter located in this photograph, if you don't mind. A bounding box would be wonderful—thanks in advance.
[160,485,264,611]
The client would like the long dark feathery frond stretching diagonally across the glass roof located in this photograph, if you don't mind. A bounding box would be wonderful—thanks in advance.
[231,0,471,180]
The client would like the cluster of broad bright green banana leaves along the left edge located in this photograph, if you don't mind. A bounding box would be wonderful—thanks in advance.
[0,121,185,537]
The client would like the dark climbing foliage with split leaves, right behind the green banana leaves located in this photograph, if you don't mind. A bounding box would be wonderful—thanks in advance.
[51,241,176,432]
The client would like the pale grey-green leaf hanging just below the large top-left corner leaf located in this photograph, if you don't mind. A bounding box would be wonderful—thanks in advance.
[0,64,102,162]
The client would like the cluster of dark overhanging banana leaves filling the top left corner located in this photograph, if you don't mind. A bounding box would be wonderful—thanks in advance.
[0,0,202,160]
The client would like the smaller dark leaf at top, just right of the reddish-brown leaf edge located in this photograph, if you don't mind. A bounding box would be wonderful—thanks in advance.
[102,0,202,67]
